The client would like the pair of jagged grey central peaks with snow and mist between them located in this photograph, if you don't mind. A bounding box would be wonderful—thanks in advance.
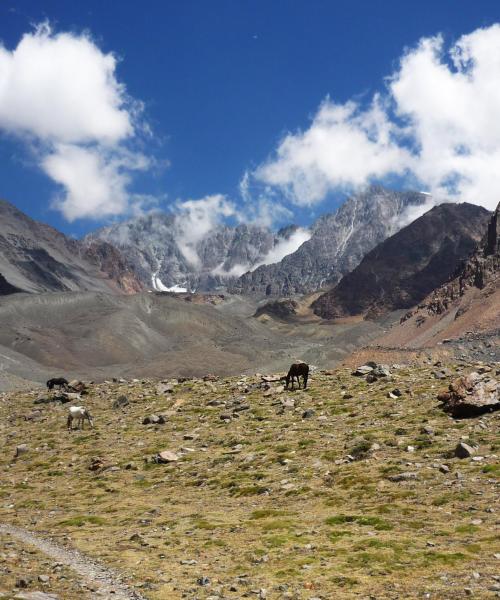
[84,186,426,297]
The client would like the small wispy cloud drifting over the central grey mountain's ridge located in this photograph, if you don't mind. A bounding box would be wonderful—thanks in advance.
[175,194,236,266]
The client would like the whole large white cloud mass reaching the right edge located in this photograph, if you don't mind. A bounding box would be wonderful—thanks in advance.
[253,24,500,209]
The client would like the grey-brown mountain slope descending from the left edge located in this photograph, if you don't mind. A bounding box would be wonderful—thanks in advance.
[0,200,143,295]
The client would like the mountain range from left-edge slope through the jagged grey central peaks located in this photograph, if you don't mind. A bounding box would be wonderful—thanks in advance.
[0,186,426,298]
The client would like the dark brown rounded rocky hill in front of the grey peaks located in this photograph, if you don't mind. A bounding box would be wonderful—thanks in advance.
[313,203,490,319]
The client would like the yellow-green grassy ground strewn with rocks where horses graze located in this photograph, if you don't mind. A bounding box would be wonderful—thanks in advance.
[0,362,500,600]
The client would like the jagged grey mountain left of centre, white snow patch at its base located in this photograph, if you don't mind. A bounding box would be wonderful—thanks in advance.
[84,212,297,291]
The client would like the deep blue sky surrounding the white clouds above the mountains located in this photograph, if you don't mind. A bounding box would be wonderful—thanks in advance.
[0,0,500,235]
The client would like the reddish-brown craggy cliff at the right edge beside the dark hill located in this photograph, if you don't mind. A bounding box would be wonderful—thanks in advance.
[402,203,500,321]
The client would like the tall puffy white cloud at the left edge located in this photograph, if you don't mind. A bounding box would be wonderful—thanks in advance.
[0,24,149,221]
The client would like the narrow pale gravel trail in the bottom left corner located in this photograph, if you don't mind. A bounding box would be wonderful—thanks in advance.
[0,523,145,600]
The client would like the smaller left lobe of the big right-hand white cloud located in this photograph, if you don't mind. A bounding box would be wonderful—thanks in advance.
[255,97,409,206]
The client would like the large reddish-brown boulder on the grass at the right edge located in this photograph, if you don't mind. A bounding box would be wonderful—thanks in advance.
[437,373,500,419]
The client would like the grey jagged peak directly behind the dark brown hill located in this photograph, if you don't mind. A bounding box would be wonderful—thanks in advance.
[232,186,426,296]
